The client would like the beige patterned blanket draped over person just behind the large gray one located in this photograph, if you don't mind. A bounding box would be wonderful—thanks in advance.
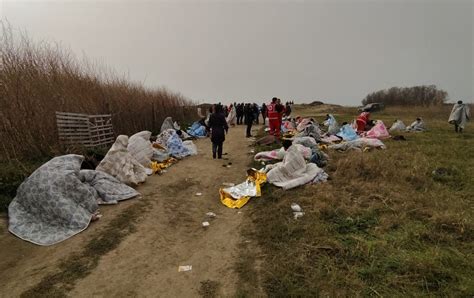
[96,135,147,185]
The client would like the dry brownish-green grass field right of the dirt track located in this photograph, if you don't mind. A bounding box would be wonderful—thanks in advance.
[237,107,474,297]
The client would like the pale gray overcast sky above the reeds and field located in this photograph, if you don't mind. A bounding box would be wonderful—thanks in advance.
[0,0,474,105]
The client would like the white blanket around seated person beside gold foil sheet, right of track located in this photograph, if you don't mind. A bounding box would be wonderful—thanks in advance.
[267,145,323,190]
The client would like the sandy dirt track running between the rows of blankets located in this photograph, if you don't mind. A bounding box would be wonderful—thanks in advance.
[0,126,260,297]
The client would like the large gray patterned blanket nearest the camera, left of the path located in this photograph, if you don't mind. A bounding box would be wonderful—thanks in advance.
[8,154,138,245]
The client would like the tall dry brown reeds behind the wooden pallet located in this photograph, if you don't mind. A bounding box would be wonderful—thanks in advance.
[0,23,195,161]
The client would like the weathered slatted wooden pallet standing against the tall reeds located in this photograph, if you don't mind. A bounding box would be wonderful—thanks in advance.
[56,112,115,148]
